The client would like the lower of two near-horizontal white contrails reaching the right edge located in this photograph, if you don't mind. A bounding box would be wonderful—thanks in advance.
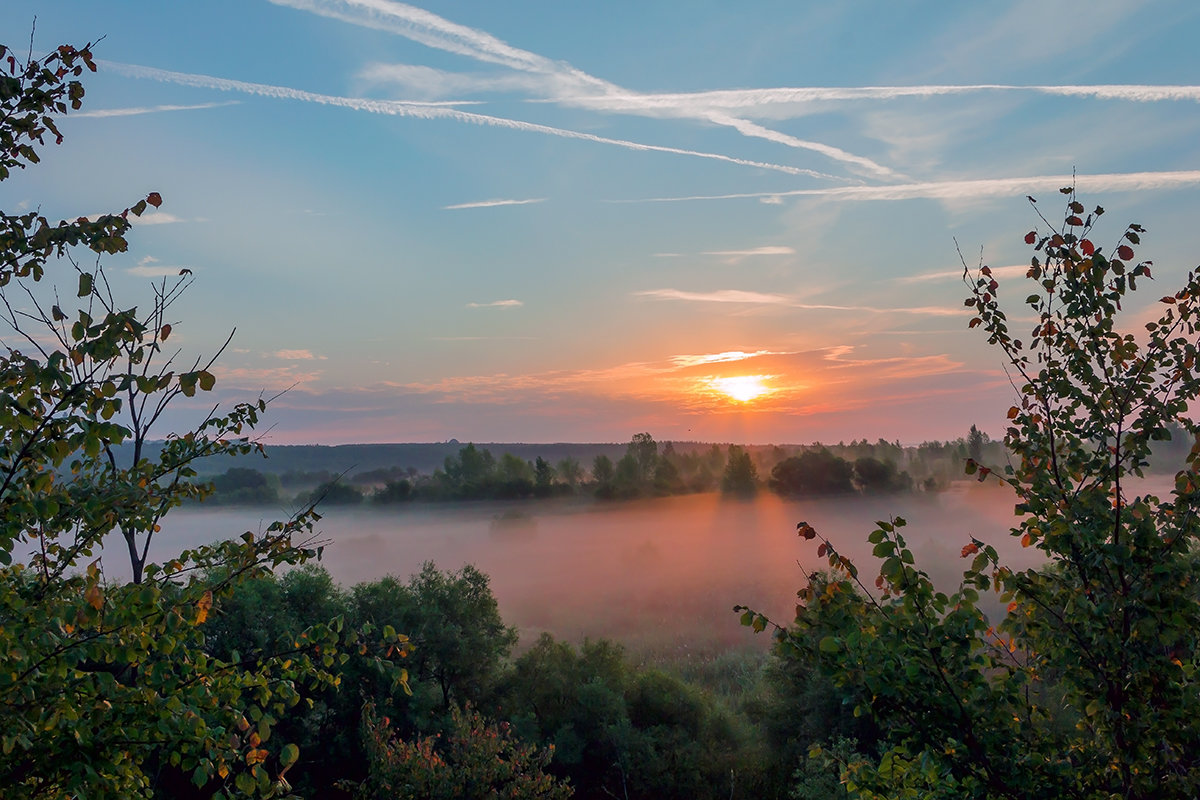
[628,169,1200,203]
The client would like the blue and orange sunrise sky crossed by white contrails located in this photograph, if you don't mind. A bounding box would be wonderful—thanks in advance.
[0,0,1200,444]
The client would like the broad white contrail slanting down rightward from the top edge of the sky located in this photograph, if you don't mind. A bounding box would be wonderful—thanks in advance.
[271,0,895,178]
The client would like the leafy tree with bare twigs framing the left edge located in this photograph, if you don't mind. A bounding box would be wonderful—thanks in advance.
[0,46,405,798]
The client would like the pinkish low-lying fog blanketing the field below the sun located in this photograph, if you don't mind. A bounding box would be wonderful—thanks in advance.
[114,483,1038,651]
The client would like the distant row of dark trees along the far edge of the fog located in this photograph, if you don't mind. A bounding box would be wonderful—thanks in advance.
[192,426,1006,505]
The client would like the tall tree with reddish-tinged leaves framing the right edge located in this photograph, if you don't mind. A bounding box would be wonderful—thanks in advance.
[743,194,1200,799]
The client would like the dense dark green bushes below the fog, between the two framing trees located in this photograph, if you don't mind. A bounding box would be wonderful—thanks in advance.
[205,564,871,800]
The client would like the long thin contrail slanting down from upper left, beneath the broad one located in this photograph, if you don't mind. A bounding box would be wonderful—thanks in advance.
[104,61,828,178]
